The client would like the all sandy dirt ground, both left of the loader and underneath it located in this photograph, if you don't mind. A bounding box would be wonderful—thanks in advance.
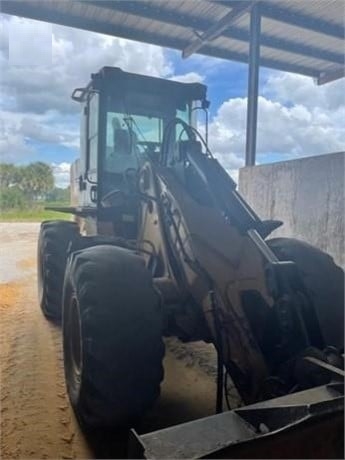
[0,223,238,459]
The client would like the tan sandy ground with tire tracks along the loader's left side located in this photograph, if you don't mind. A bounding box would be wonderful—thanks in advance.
[0,223,91,459]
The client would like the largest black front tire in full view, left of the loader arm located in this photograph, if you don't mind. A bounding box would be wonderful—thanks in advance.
[63,245,164,430]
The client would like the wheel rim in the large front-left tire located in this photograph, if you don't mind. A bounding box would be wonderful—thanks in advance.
[65,296,83,398]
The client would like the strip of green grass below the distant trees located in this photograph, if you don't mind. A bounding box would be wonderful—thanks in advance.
[0,203,72,222]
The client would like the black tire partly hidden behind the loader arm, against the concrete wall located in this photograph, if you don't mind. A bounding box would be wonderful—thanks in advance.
[266,238,344,350]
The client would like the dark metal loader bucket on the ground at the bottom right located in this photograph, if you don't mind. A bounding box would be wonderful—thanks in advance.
[129,383,344,459]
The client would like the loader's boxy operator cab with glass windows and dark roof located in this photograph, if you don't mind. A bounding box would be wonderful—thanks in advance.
[72,67,206,225]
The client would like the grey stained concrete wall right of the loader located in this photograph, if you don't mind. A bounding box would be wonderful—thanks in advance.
[239,152,345,267]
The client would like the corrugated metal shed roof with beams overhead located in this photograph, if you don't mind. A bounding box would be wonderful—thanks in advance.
[1,0,345,84]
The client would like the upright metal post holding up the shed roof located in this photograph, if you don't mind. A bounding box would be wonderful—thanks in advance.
[246,5,261,166]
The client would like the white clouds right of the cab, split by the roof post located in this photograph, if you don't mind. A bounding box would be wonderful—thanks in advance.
[209,72,345,180]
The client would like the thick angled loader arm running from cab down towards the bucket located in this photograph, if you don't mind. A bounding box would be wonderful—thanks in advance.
[139,121,342,403]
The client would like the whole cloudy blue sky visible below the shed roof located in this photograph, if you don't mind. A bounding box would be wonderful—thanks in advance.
[0,15,345,187]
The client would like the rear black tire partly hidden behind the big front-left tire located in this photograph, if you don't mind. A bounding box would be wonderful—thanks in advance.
[37,220,79,321]
